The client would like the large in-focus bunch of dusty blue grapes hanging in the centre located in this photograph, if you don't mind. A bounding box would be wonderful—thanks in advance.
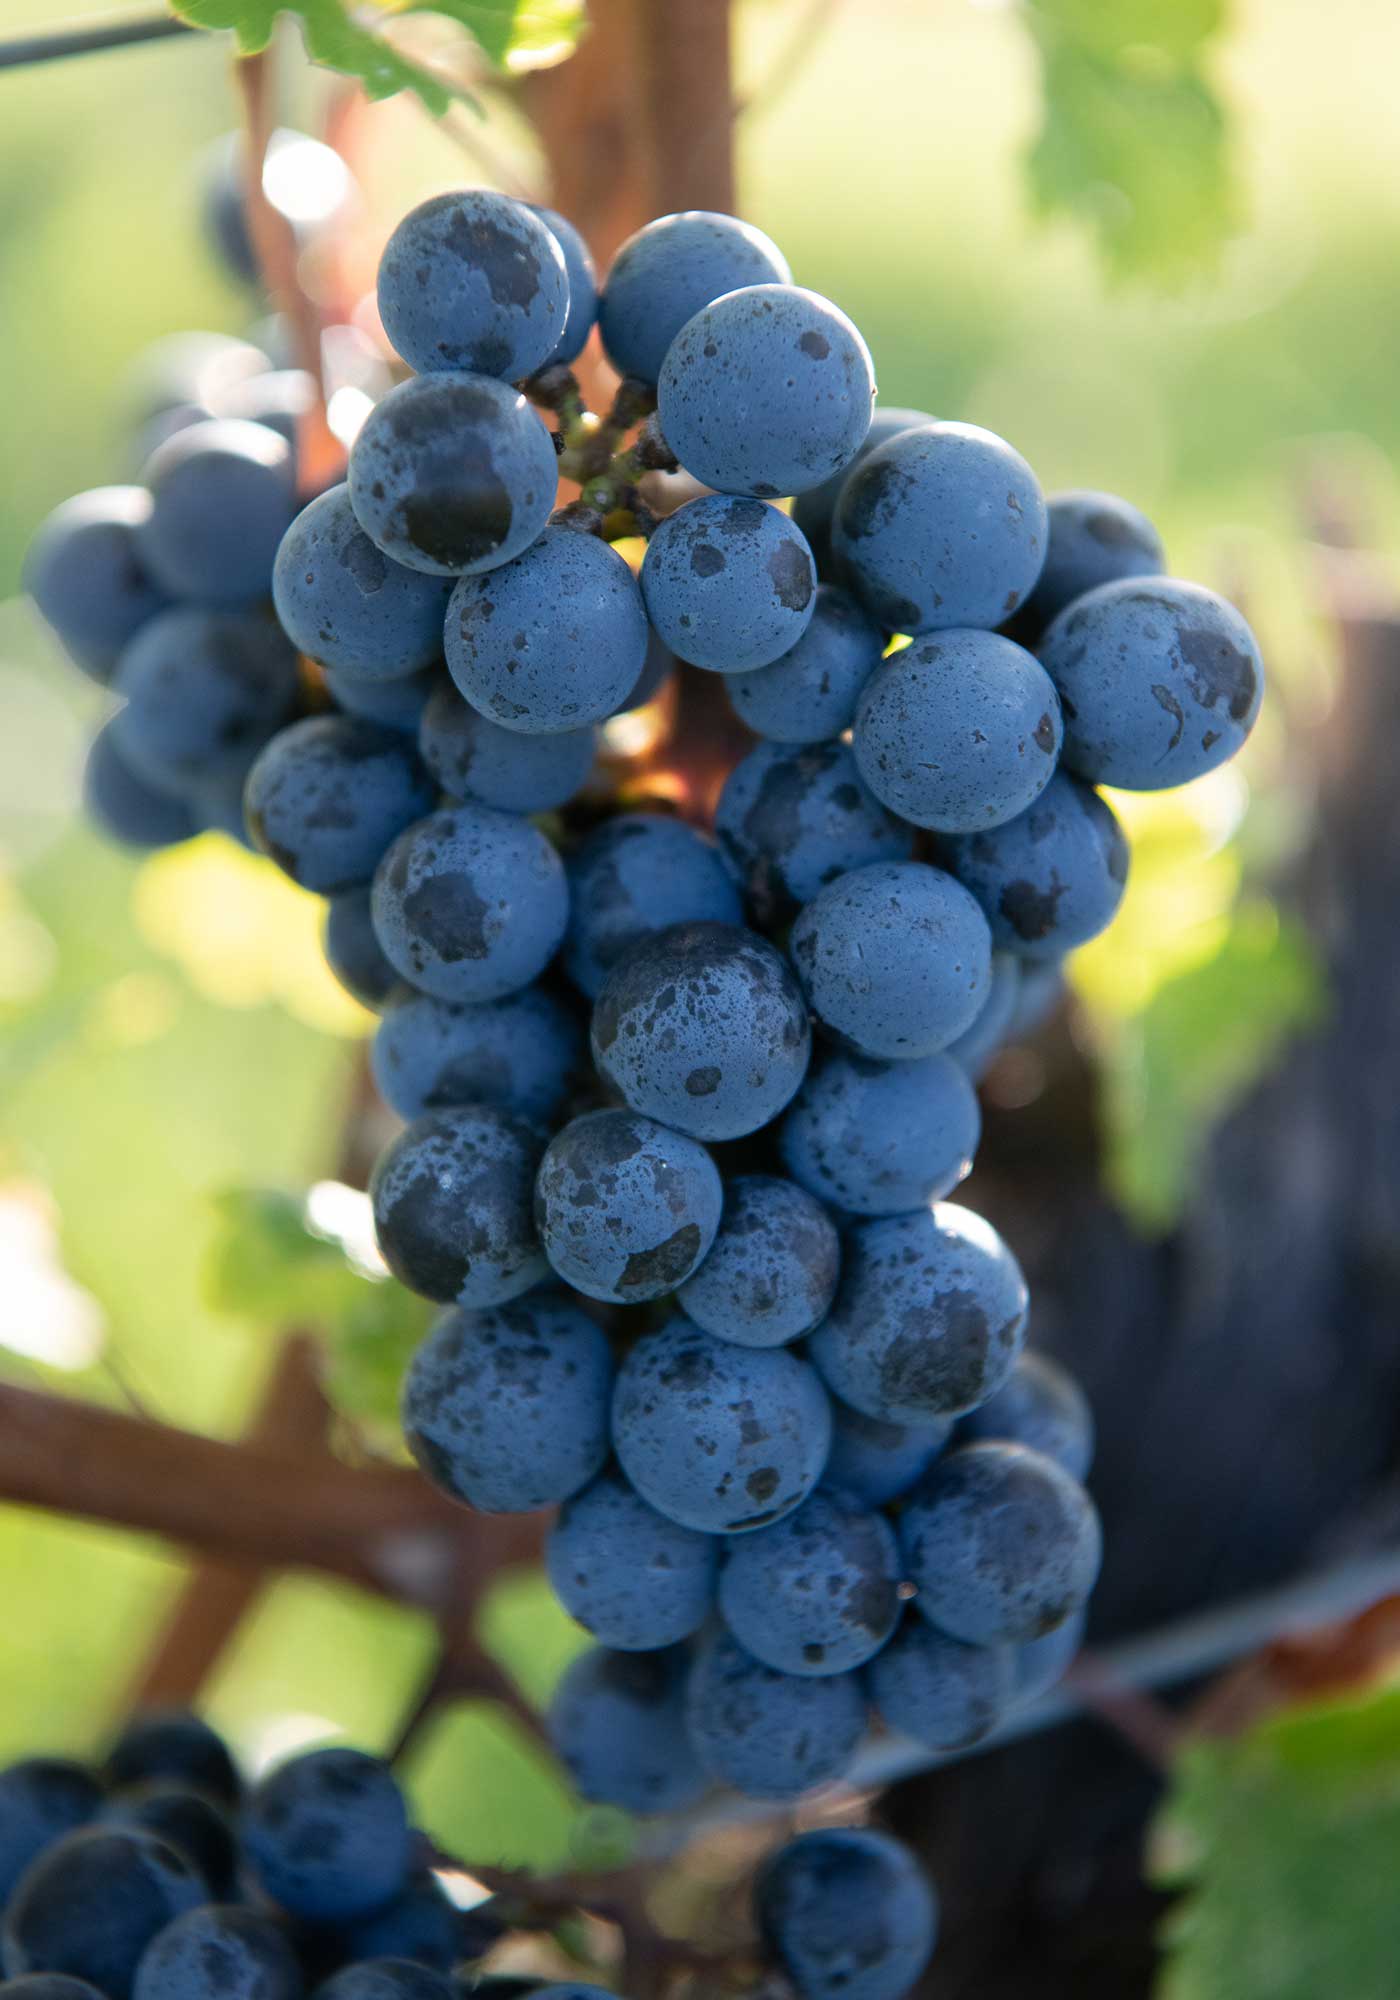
[24,192,1262,1812]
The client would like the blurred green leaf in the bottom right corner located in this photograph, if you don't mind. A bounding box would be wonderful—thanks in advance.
[1150,1688,1400,2000]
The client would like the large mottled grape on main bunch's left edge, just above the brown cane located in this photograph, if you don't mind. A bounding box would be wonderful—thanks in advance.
[402,1290,612,1514]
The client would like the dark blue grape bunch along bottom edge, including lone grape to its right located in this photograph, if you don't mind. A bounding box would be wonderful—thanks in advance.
[0,1710,938,2000]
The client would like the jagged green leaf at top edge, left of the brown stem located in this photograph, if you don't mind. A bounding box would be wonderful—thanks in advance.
[172,0,584,116]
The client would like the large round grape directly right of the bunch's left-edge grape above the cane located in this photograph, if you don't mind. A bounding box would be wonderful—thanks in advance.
[612,1314,832,1534]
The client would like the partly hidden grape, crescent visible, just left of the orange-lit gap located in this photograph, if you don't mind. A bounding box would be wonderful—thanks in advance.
[418,680,598,812]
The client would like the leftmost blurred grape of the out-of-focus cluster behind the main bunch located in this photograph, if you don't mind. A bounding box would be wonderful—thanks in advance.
[24,486,170,680]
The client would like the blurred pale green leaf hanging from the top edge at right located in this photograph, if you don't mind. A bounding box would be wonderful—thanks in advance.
[1026,0,1238,284]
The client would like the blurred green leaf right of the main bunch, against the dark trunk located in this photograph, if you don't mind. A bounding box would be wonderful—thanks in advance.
[1100,902,1324,1230]
